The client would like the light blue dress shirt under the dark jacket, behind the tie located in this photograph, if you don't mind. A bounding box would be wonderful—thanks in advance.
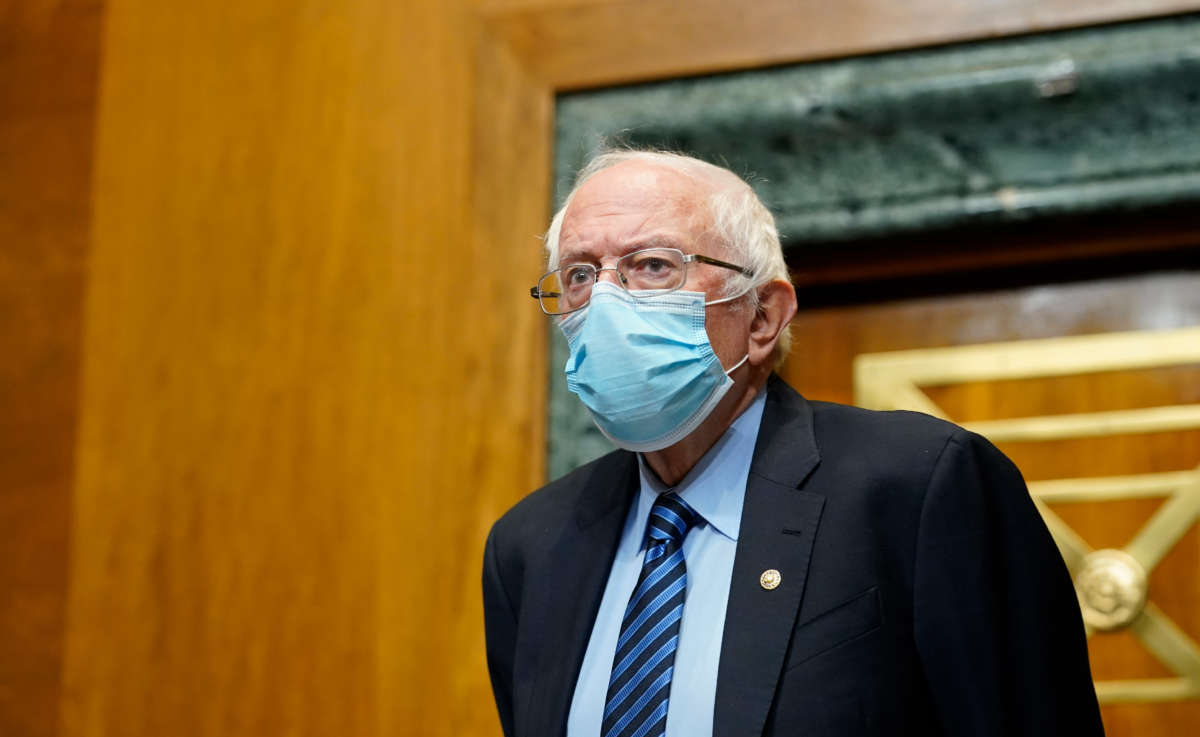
[566,391,767,737]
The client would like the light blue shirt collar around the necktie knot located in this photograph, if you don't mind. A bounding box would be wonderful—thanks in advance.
[634,390,767,544]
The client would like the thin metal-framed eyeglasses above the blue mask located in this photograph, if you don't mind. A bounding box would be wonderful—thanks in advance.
[529,248,754,314]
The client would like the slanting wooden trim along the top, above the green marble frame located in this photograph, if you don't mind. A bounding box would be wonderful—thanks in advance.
[478,0,1196,89]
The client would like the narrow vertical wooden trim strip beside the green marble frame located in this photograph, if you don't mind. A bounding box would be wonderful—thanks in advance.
[448,25,553,735]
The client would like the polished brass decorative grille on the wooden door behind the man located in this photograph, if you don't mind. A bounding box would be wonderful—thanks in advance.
[854,326,1200,703]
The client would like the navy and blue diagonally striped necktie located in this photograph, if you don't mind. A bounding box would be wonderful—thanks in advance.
[600,491,700,737]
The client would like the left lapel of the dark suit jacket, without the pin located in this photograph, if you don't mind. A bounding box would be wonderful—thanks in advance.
[517,453,637,737]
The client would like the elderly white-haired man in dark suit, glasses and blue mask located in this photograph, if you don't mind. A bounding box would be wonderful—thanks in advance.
[484,151,1103,737]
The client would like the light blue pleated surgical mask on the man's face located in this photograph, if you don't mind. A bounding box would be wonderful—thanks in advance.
[559,282,749,453]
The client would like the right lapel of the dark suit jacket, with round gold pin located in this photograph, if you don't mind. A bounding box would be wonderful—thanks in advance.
[713,376,824,737]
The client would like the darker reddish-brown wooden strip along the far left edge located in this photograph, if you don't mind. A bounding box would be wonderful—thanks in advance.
[0,0,103,737]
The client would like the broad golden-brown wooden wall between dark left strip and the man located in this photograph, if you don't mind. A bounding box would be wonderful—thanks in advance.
[57,0,548,737]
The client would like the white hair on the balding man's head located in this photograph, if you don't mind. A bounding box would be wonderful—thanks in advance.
[545,149,792,362]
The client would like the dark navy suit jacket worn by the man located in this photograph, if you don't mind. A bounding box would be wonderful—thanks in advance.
[484,377,1103,737]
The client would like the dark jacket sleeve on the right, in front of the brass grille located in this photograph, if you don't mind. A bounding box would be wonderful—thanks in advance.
[913,430,1104,737]
